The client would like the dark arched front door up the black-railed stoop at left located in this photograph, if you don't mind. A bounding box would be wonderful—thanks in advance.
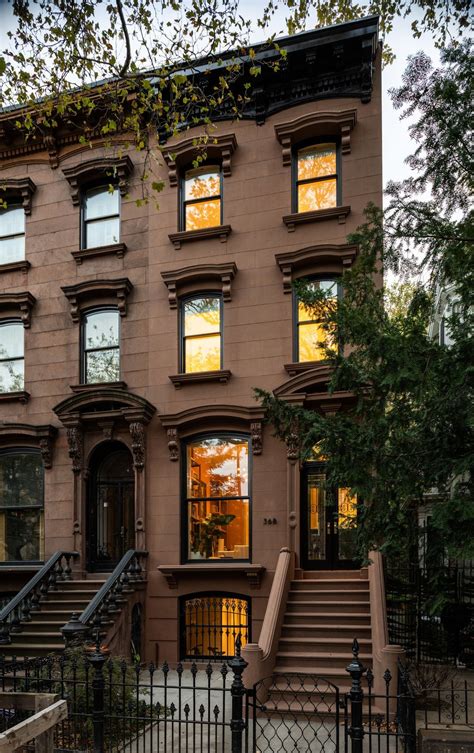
[87,442,135,572]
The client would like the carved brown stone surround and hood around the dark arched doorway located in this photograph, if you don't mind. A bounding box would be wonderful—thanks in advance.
[54,385,156,561]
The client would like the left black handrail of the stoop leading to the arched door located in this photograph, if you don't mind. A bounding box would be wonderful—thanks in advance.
[0,551,79,644]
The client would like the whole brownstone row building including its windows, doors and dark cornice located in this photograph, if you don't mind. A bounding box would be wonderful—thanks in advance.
[0,18,382,666]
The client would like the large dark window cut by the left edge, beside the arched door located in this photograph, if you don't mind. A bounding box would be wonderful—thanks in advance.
[0,450,44,562]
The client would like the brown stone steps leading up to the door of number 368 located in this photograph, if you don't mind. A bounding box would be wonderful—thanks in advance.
[265,570,372,713]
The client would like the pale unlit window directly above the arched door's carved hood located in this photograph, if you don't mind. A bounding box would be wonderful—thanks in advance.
[82,308,120,384]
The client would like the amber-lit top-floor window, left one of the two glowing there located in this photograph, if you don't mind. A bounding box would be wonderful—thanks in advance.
[181,165,222,230]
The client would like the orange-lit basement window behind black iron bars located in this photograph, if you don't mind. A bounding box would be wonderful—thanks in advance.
[181,593,250,660]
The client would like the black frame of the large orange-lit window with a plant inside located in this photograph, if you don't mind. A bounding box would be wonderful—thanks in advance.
[180,430,253,566]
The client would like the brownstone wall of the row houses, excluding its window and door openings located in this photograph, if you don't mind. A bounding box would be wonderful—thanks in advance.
[0,21,382,661]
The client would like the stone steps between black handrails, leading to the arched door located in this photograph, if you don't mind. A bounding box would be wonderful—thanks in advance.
[0,576,106,658]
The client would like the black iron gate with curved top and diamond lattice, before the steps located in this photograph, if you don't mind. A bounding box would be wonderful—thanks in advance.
[247,674,348,753]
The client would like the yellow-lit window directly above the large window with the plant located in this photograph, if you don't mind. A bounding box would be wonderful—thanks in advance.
[181,295,222,374]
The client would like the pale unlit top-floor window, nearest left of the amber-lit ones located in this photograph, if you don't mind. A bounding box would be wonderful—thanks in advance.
[81,186,120,248]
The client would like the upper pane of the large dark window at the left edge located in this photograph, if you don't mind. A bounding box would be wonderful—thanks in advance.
[0,452,44,508]
